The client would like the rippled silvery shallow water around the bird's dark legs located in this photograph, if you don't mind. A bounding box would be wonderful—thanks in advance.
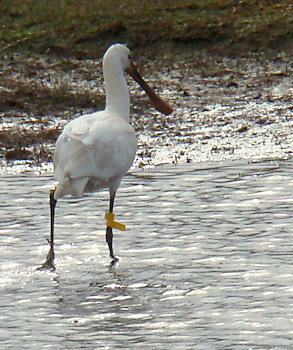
[0,161,293,349]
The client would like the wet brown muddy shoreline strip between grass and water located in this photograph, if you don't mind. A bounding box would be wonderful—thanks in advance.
[0,49,293,171]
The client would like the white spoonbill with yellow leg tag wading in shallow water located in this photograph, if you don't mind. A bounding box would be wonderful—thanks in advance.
[40,44,172,269]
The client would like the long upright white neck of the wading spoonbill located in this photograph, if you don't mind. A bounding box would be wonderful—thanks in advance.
[103,62,129,122]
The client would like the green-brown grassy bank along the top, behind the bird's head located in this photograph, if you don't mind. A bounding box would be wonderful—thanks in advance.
[0,0,293,57]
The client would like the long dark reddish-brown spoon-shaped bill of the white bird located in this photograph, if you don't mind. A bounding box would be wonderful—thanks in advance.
[125,63,173,115]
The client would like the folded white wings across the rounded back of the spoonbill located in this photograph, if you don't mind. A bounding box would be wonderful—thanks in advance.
[54,112,137,181]
